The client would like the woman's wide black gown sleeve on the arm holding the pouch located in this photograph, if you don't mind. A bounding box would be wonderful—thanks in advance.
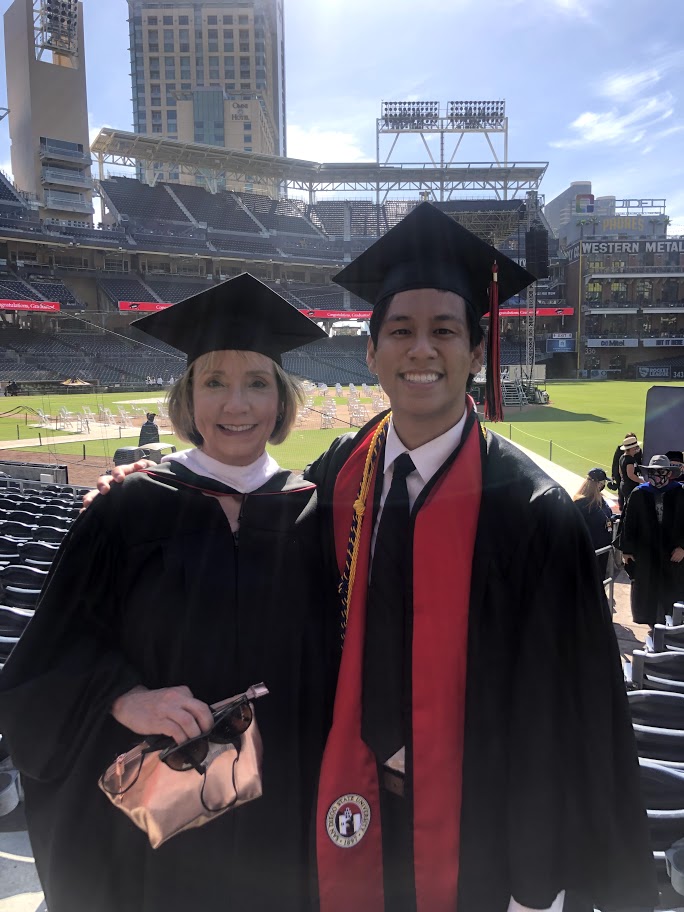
[0,492,140,781]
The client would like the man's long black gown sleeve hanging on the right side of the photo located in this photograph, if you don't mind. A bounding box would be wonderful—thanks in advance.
[509,488,657,912]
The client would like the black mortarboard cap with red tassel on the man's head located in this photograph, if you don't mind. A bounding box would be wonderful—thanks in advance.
[333,203,534,319]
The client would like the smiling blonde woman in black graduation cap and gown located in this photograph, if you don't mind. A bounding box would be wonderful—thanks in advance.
[0,274,334,912]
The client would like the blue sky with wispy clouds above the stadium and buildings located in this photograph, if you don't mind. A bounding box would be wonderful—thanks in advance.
[0,0,684,234]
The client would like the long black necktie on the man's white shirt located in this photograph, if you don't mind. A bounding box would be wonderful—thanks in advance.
[361,453,416,762]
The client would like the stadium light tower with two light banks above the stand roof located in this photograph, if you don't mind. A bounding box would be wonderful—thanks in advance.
[376,100,508,200]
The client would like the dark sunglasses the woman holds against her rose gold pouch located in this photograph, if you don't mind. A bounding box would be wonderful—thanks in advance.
[102,684,268,795]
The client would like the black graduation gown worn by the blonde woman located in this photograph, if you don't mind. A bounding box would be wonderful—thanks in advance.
[0,463,334,912]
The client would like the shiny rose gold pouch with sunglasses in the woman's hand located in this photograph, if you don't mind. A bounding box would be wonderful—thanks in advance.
[98,684,268,849]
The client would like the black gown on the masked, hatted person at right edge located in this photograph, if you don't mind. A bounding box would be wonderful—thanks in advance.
[620,482,684,627]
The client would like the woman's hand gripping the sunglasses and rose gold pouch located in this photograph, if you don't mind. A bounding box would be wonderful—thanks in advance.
[111,686,214,744]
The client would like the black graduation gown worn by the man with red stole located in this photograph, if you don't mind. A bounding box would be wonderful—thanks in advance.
[306,416,657,912]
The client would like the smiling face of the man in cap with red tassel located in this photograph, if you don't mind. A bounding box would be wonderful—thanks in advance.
[366,288,484,449]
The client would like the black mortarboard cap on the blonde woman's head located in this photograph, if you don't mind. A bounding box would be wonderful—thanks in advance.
[131,272,327,364]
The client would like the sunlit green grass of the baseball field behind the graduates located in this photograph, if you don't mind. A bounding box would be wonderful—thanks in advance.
[6,381,684,475]
